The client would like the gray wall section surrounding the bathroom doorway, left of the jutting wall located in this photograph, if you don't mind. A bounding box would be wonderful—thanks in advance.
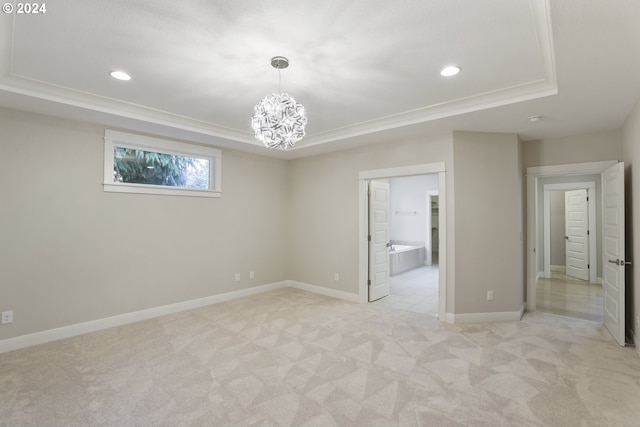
[288,134,453,306]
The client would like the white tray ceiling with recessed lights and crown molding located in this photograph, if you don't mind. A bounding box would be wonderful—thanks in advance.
[0,0,640,158]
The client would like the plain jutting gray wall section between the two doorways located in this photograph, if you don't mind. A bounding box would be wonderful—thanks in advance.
[453,132,524,314]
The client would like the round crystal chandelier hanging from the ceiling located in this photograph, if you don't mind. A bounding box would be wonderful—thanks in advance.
[251,56,307,150]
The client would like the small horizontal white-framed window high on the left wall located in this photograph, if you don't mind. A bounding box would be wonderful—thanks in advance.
[103,129,222,197]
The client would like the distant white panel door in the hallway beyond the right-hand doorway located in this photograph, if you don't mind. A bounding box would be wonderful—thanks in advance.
[564,189,589,280]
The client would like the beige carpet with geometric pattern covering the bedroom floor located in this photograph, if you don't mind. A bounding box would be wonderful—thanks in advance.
[0,289,640,427]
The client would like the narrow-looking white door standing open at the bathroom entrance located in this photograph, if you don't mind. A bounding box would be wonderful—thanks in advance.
[368,181,389,301]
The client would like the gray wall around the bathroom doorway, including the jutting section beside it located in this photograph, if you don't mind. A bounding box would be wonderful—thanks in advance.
[289,132,523,314]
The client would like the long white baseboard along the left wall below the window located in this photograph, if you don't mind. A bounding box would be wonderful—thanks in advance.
[0,280,289,353]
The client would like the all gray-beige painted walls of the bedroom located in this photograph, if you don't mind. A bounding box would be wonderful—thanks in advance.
[0,98,640,339]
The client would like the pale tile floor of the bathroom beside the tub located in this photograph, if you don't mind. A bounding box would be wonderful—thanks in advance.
[375,264,438,317]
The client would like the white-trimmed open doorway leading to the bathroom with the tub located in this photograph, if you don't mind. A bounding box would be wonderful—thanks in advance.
[360,163,446,321]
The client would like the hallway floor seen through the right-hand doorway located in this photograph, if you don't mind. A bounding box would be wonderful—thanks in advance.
[536,271,604,322]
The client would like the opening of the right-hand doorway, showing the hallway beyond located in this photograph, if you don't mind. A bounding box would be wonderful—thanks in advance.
[536,182,604,323]
